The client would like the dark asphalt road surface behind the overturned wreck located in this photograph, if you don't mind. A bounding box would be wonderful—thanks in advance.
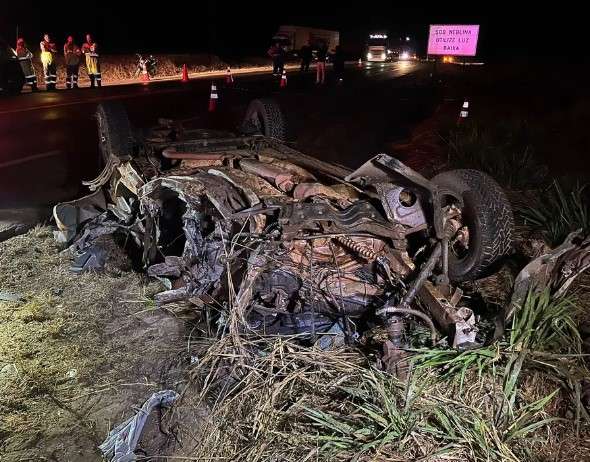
[0,63,434,209]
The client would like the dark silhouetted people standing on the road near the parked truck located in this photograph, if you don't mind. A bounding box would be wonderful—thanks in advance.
[267,42,344,85]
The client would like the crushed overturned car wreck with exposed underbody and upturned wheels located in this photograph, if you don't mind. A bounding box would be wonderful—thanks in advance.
[54,100,513,374]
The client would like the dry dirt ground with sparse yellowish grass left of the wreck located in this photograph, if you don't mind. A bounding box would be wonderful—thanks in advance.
[0,227,189,462]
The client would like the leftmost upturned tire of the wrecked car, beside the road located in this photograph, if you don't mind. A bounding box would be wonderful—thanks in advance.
[96,102,133,165]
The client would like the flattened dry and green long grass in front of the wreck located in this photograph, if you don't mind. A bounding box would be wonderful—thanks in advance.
[184,293,589,461]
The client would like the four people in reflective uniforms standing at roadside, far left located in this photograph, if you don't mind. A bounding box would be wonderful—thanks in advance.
[16,34,102,91]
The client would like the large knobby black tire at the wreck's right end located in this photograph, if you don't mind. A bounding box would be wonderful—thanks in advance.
[432,169,514,282]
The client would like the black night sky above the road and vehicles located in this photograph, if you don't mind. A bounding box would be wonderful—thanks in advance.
[0,0,587,59]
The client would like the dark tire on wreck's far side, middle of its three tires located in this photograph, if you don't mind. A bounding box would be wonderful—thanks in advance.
[241,98,287,142]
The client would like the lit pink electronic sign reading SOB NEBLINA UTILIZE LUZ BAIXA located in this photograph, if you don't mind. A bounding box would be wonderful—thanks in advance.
[428,24,479,56]
